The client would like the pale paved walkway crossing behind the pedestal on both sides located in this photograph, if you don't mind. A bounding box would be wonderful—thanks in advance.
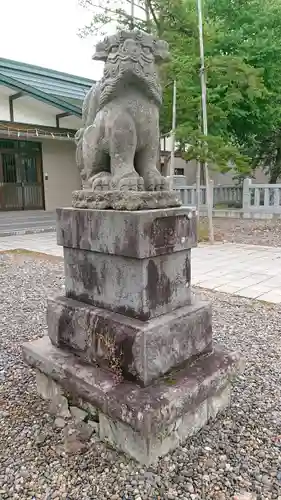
[0,233,281,304]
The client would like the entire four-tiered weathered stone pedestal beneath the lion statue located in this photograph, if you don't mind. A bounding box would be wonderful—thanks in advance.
[23,195,239,464]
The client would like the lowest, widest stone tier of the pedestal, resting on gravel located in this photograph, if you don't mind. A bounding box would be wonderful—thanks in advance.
[23,336,239,464]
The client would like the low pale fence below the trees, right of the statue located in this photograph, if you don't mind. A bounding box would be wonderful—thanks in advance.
[174,178,281,218]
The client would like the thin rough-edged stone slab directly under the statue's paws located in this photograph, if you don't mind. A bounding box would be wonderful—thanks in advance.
[72,189,182,211]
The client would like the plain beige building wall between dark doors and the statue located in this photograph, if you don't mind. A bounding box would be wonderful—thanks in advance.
[42,139,81,211]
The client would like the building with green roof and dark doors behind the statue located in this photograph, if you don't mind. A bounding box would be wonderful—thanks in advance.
[0,58,95,210]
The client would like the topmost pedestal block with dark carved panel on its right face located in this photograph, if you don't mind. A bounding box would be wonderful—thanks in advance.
[57,205,197,259]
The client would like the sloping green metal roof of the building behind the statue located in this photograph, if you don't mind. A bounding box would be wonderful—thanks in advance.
[0,58,95,116]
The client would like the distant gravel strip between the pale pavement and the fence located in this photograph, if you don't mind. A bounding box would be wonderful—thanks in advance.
[202,217,281,247]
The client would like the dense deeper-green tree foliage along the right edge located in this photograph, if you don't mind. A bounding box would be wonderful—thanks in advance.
[208,0,281,182]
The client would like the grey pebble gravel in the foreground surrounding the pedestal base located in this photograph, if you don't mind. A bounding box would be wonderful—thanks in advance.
[0,254,281,500]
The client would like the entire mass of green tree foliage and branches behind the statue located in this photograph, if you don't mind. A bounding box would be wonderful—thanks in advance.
[78,0,281,182]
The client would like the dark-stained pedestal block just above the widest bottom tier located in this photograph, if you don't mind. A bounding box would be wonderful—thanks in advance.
[47,297,212,385]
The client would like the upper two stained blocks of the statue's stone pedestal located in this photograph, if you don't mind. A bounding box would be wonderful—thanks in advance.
[57,206,197,321]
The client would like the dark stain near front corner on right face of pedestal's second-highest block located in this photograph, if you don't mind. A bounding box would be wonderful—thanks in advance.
[146,259,172,309]
